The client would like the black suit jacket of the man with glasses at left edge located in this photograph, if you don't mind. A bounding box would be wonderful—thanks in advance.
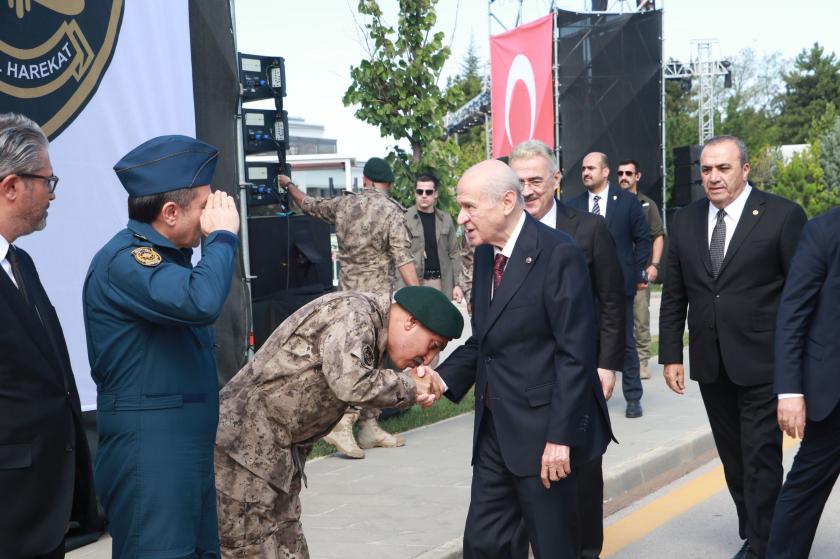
[0,249,98,558]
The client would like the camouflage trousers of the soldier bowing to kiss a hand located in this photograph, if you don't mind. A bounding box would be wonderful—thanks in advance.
[215,448,309,559]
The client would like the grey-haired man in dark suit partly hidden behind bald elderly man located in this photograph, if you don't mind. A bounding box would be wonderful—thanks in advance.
[509,140,626,557]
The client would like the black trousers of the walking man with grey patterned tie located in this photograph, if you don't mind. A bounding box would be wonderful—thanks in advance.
[698,366,783,557]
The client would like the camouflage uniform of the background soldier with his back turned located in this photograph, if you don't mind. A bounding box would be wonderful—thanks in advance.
[301,188,414,423]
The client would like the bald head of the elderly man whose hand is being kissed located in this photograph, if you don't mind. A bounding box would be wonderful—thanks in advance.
[458,159,525,248]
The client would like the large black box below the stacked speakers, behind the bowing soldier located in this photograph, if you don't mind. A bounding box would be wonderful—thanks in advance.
[248,215,333,302]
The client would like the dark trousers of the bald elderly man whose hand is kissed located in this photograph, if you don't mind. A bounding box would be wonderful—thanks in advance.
[464,410,577,559]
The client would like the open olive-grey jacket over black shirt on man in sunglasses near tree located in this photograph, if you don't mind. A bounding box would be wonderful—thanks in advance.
[397,205,461,299]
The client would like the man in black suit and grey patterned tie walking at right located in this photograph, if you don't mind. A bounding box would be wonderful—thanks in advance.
[659,136,806,557]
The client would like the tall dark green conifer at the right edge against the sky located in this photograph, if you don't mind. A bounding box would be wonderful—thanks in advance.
[779,43,840,144]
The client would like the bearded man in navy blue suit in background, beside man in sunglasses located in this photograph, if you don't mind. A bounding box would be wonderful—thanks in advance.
[569,152,651,418]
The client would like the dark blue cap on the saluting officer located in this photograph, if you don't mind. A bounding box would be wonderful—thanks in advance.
[114,136,219,196]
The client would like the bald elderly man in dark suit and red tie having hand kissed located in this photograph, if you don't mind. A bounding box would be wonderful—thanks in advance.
[439,161,610,559]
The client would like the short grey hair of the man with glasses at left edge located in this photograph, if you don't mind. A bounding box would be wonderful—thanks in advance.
[0,113,50,177]
